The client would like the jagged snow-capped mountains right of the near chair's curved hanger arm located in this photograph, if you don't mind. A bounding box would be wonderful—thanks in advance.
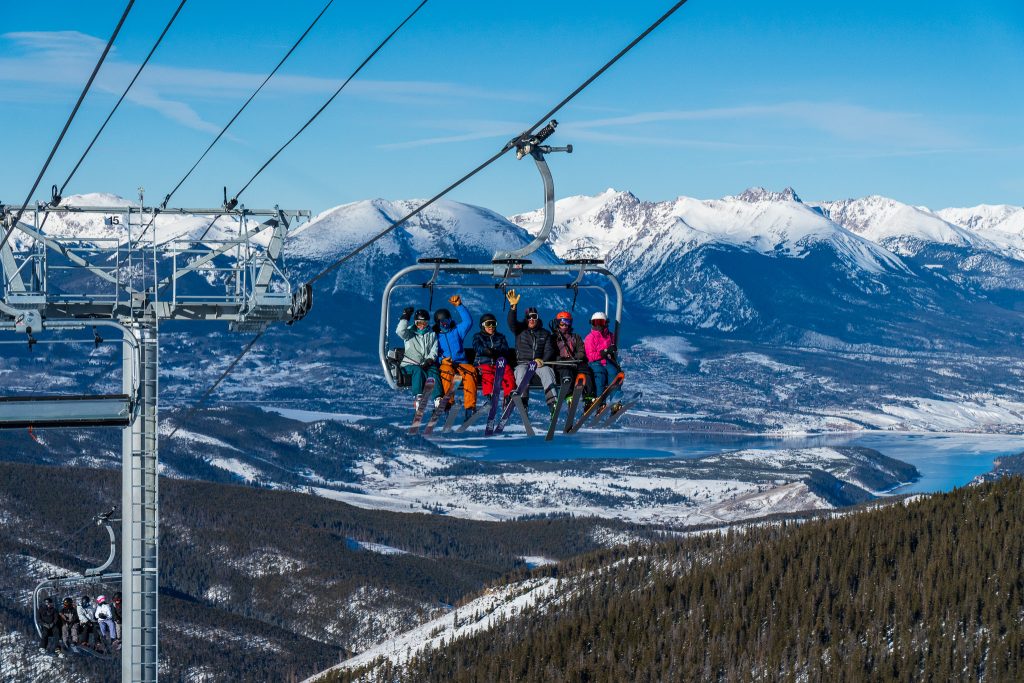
[510,188,1024,345]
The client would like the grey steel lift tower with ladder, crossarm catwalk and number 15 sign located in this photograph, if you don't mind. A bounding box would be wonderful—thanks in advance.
[0,198,312,683]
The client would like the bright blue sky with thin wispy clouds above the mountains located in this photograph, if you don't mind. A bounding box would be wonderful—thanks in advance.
[0,0,1024,213]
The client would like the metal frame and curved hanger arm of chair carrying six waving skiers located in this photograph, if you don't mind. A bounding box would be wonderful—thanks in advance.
[378,120,623,389]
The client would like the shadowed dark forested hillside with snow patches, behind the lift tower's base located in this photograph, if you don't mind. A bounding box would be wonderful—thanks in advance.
[0,463,639,683]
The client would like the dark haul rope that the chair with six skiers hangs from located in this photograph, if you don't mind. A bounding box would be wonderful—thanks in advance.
[176,0,687,421]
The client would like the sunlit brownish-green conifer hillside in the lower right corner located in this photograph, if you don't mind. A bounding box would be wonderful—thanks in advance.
[335,477,1024,683]
